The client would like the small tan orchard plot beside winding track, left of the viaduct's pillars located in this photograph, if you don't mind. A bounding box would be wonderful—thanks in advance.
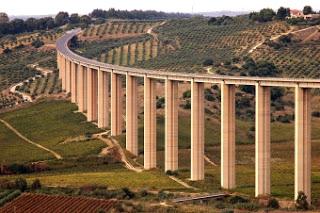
[17,73,61,98]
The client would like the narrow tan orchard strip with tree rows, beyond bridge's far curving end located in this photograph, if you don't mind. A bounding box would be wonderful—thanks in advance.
[82,21,158,38]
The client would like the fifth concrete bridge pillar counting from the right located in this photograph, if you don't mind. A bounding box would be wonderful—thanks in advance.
[165,79,178,171]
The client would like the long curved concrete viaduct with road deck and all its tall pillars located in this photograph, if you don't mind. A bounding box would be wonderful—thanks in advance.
[56,29,320,201]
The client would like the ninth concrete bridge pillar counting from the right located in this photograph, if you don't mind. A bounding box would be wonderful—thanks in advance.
[98,70,109,128]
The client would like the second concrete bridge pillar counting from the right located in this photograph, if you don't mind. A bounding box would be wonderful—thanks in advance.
[255,84,270,196]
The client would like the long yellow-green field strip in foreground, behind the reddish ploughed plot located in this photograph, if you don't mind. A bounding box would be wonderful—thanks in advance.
[0,166,183,190]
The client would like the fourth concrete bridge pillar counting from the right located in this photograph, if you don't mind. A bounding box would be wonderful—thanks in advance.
[191,81,204,181]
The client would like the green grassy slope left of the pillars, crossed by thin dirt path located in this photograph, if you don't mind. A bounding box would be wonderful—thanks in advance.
[0,101,105,161]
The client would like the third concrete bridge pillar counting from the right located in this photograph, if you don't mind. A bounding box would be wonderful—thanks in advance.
[221,83,236,189]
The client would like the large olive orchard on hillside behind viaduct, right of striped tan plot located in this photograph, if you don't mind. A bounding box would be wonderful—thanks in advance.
[134,18,290,72]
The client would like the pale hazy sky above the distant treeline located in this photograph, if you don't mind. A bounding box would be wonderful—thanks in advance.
[0,0,320,15]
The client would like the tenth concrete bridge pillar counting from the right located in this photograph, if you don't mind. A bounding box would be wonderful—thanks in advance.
[87,68,98,122]
